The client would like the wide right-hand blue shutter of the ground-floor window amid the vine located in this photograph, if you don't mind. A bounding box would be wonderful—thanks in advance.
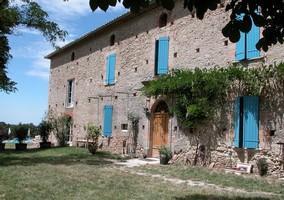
[243,96,259,149]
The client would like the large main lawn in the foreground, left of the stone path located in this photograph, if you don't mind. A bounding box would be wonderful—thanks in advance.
[0,147,281,200]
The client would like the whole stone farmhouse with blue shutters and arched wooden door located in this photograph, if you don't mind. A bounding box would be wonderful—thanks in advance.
[46,0,284,174]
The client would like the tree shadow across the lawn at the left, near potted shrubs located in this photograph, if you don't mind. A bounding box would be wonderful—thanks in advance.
[0,147,121,166]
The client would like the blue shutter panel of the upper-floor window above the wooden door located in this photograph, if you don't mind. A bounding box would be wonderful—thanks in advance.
[157,37,169,75]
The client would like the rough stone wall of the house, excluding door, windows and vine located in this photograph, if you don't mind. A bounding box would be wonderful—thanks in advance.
[48,1,284,177]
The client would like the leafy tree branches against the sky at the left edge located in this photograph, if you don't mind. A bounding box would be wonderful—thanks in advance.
[0,0,67,93]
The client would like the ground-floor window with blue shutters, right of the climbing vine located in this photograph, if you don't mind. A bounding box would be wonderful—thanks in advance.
[234,96,259,149]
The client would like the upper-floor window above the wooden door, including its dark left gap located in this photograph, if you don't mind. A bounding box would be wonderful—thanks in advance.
[155,37,169,75]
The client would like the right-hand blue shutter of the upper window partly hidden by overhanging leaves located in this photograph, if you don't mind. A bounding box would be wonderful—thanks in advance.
[247,20,260,59]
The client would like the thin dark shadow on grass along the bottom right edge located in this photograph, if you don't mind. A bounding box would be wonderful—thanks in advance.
[175,194,270,200]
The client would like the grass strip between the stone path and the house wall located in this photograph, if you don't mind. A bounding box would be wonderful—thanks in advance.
[136,165,284,195]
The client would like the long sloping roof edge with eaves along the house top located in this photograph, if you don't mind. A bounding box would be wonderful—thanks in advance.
[44,5,159,59]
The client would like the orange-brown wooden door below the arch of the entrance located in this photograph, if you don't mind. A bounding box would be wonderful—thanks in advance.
[151,113,169,157]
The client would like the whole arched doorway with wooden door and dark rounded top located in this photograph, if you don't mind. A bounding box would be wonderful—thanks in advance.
[149,101,169,157]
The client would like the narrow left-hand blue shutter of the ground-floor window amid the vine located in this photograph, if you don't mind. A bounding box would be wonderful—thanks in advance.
[234,97,241,147]
